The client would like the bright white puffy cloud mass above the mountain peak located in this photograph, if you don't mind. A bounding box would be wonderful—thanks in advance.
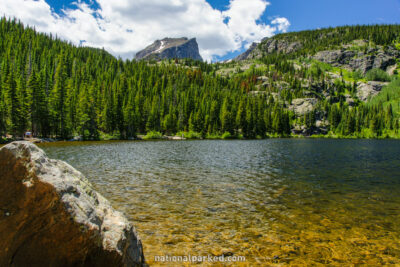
[0,0,290,60]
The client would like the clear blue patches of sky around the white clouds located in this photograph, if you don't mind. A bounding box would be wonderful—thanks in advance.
[46,0,400,31]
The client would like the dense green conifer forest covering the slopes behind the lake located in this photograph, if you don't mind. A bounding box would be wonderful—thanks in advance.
[0,18,400,140]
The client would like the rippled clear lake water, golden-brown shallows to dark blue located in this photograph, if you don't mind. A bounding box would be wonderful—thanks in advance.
[41,139,400,266]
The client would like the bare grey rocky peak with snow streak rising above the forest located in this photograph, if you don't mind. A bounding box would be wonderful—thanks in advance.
[136,37,203,60]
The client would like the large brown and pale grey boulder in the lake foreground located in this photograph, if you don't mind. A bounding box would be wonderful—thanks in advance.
[0,142,145,266]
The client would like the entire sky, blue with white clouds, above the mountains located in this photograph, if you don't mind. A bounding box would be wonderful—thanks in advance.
[0,0,400,61]
